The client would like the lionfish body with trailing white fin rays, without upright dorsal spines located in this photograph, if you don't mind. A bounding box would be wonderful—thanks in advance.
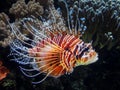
[10,19,98,84]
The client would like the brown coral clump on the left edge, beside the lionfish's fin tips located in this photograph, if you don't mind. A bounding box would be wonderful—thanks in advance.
[0,13,14,47]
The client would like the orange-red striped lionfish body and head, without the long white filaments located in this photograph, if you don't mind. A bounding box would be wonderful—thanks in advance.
[28,32,97,77]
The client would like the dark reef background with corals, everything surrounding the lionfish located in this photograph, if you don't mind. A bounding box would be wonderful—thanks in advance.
[0,0,120,90]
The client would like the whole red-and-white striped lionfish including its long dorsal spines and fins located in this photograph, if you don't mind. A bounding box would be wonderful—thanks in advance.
[9,0,98,84]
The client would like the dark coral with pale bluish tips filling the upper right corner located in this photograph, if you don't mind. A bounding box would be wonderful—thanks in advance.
[63,0,120,50]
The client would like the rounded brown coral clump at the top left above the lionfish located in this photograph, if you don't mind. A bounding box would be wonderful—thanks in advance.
[9,0,44,19]
